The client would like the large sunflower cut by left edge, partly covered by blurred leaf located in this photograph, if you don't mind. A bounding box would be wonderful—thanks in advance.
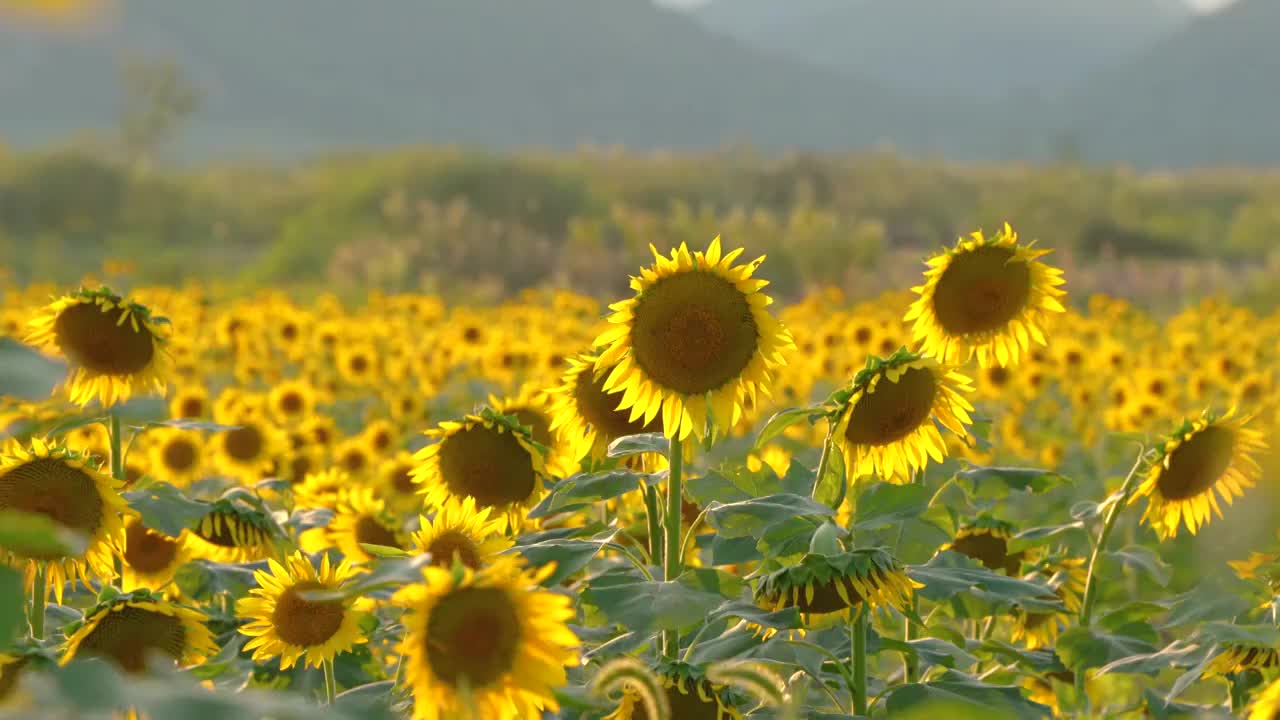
[0,438,129,603]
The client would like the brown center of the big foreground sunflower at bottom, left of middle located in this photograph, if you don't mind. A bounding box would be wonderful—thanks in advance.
[424,588,521,688]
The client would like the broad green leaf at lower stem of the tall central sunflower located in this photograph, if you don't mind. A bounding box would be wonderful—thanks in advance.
[582,573,741,632]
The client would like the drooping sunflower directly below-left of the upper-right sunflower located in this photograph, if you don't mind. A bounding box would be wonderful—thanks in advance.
[828,347,973,483]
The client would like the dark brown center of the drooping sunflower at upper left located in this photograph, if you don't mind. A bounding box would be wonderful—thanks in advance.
[54,302,155,375]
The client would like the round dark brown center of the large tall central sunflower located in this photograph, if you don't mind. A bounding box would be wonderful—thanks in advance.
[631,272,759,395]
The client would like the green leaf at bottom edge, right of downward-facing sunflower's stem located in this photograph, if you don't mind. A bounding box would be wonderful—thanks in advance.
[884,670,1052,720]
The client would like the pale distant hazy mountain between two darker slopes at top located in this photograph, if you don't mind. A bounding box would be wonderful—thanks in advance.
[695,0,1192,99]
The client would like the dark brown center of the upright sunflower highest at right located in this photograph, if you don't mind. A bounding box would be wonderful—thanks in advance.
[933,246,1032,336]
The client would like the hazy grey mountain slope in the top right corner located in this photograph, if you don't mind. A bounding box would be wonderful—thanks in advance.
[1062,0,1280,165]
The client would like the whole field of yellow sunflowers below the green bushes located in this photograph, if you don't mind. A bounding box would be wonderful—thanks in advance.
[0,224,1280,720]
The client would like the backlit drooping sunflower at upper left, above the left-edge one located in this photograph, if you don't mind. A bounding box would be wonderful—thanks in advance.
[27,288,169,407]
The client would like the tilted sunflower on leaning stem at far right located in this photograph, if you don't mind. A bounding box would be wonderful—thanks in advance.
[1133,411,1266,539]
